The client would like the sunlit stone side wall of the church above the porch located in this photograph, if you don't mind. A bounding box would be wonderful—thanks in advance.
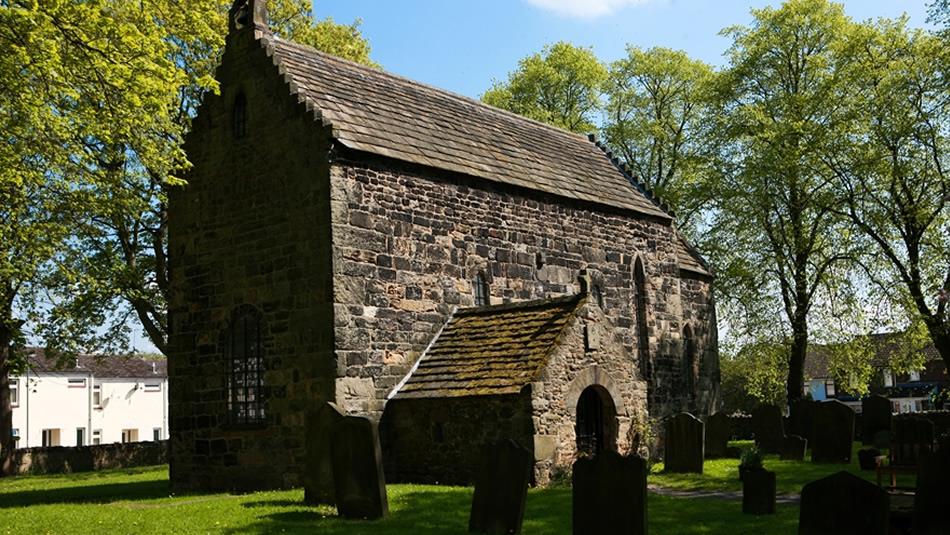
[331,150,715,416]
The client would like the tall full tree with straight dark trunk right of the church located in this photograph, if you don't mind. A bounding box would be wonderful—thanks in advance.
[705,0,850,401]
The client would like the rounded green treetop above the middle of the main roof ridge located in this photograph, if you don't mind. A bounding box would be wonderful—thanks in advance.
[482,42,607,134]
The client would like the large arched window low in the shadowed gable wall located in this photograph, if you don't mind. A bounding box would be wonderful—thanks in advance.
[227,307,264,424]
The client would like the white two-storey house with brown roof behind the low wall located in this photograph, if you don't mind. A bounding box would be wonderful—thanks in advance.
[10,349,168,448]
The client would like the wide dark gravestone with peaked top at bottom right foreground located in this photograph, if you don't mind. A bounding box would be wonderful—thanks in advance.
[798,471,890,535]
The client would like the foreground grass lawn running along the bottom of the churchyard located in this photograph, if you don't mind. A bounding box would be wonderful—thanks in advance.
[0,466,798,535]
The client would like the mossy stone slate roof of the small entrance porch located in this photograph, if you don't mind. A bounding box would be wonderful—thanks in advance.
[394,295,584,399]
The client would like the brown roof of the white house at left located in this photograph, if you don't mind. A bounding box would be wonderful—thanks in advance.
[19,348,168,378]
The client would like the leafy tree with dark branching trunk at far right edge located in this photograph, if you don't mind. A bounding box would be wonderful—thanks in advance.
[823,18,950,376]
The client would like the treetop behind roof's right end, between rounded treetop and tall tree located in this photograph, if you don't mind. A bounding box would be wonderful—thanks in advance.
[603,47,713,225]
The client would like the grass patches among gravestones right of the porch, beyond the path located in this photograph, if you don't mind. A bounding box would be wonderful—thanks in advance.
[649,441,915,494]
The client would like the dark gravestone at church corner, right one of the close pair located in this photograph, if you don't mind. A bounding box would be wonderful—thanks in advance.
[331,416,389,519]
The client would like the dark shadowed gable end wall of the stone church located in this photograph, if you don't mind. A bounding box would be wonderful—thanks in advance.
[169,31,335,490]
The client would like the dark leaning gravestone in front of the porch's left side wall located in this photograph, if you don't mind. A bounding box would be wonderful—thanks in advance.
[468,440,532,534]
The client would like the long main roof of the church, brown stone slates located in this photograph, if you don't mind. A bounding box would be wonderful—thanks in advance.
[261,34,672,220]
